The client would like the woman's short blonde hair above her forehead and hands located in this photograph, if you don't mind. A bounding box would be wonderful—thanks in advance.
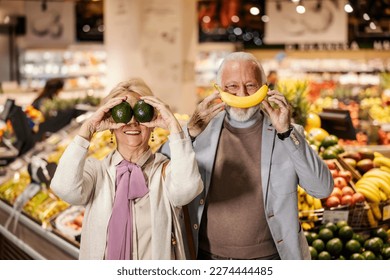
[101,78,153,104]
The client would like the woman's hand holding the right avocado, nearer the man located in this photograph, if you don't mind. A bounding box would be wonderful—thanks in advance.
[140,96,182,133]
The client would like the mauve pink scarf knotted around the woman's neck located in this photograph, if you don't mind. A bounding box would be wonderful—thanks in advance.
[106,160,149,260]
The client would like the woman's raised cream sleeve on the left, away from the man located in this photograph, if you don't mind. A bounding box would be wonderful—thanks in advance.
[50,135,96,205]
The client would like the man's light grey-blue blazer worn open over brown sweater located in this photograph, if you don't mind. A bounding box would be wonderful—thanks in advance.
[161,112,333,260]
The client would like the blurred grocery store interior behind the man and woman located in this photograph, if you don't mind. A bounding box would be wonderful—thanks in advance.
[0,0,390,260]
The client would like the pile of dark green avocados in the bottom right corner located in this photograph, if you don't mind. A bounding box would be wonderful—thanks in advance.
[305,220,390,260]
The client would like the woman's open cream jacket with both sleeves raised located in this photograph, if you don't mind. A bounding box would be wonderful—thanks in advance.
[51,134,203,260]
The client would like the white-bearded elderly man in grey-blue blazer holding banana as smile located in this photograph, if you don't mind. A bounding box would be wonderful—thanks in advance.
[162,52,333,260]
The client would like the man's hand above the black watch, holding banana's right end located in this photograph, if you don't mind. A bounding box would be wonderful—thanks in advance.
[262,90,291,133]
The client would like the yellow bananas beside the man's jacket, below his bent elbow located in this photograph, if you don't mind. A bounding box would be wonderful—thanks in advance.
[298,186,323,230]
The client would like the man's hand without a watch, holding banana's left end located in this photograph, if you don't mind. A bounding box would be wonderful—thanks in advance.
[187,92,225,138]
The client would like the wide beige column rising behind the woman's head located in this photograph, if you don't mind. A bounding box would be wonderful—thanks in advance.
[104,0,198,114]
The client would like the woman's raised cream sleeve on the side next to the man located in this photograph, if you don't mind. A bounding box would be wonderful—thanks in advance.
[165,134,203,206]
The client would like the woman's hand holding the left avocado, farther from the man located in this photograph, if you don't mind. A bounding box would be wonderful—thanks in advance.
[79,96,127,140]
